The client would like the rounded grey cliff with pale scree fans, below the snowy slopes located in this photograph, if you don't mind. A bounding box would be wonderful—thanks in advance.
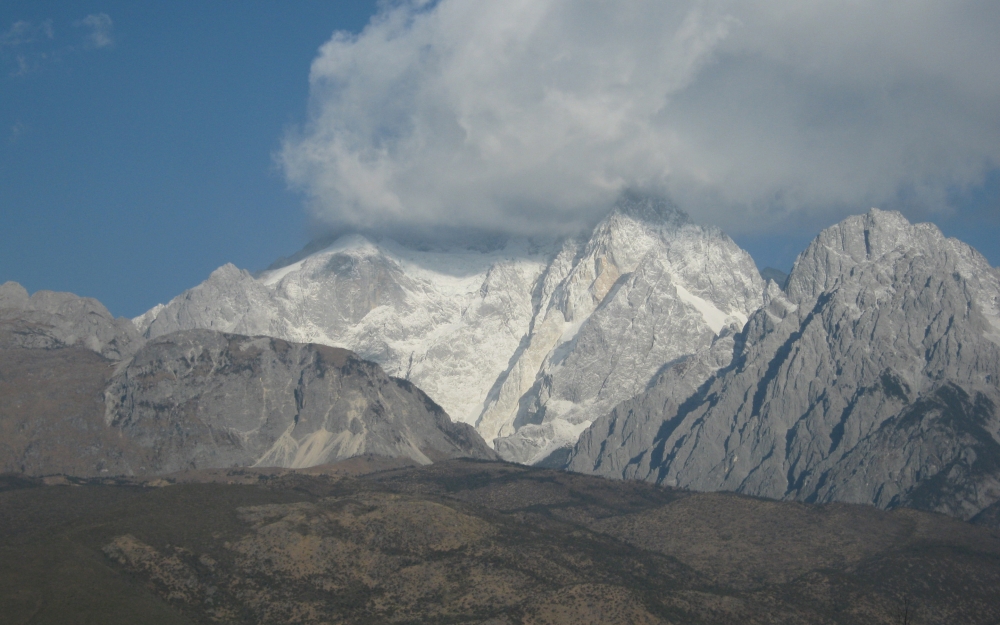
[105,330,496,473]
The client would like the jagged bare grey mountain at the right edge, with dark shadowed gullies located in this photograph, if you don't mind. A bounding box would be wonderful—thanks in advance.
[568,209,1000,519]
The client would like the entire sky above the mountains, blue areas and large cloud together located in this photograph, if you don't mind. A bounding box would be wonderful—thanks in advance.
[0,0,1000,316]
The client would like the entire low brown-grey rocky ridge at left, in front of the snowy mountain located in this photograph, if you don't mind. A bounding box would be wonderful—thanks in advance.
[0,283,496,476]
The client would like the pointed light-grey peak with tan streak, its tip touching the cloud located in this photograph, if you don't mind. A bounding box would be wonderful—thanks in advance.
[488,196,763,463]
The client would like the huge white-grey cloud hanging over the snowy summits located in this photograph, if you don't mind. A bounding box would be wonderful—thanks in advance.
[279,0,1000,233]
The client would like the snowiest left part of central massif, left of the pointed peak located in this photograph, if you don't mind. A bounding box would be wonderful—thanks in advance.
[140,235,551,434]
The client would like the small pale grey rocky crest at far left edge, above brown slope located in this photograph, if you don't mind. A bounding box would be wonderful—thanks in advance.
[0,282,142,360]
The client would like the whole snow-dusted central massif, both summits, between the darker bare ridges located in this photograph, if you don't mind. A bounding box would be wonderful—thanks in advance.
[135,195,763,462]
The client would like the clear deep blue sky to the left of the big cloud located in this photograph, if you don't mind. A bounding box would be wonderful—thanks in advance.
[0,0,375,316]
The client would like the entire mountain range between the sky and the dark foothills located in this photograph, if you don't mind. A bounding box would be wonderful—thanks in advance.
[0,200,1000,524]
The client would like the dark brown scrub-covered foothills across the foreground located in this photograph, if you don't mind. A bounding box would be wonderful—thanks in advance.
[0,458,1000,625]
